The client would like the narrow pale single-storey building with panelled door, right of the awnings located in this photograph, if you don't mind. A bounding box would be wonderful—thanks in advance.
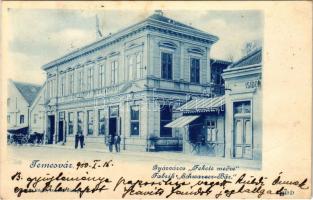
[223,49,262,160]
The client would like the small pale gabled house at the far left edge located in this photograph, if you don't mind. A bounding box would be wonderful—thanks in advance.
[7,80,41,130]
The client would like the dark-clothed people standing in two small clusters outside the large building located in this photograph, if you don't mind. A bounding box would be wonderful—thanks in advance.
[75,132,121,152]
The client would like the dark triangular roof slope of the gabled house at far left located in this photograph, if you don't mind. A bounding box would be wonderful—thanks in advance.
[13,81,41,105]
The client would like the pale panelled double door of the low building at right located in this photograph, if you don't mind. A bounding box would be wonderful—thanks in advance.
[234,118,253,159]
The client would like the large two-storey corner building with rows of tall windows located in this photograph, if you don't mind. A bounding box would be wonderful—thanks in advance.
[42,11,218,151]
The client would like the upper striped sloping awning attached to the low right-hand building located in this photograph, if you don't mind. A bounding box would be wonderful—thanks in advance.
[176,96,225,113]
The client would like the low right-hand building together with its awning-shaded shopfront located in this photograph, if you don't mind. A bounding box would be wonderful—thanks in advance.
[166,49,262,167]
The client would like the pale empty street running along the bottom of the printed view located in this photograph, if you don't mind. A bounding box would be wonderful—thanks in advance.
[7,145,258,169]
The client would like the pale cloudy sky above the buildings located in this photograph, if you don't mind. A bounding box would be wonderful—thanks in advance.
[8,9,263,84]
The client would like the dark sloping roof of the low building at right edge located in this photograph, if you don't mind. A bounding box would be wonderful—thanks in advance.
[228,48,262,69]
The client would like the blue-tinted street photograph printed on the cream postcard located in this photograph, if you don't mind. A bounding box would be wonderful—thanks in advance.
[7,9,263,168]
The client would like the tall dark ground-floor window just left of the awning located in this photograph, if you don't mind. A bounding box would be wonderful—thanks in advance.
[160,105,172,137]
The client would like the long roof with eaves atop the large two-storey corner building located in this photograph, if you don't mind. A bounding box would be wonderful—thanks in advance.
[42,11,218,69]
